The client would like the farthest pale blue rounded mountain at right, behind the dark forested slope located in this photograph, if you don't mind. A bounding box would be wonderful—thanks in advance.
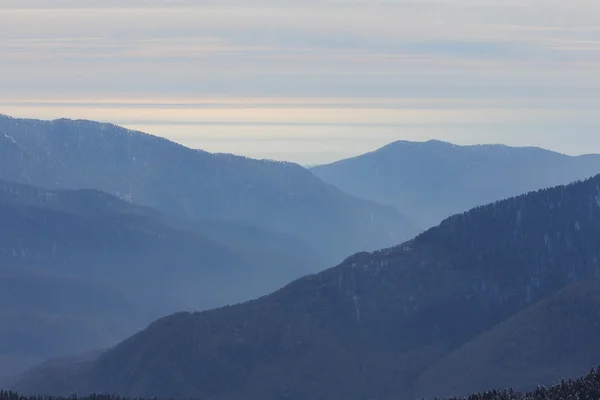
[311,140,600,227]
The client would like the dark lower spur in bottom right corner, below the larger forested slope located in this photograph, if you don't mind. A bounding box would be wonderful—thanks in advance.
[417,280,600,398]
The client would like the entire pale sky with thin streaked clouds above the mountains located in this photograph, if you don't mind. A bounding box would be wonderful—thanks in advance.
[0,0,600,165]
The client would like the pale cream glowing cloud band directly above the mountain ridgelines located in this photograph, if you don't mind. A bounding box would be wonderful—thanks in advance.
[0,97,600,164]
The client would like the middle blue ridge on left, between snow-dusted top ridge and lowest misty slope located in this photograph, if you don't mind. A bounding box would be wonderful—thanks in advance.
[0,180,322,312]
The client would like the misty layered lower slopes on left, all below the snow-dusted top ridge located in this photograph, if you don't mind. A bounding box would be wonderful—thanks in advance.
[0,180,325,376]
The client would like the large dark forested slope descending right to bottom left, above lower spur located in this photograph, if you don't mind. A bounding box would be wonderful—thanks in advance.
[16,176,600,400]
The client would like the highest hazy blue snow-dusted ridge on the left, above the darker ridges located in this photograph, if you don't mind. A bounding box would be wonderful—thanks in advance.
[0,116,418,262]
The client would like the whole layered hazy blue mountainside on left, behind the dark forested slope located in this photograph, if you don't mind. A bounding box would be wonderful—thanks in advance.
[0,116,418,376]
